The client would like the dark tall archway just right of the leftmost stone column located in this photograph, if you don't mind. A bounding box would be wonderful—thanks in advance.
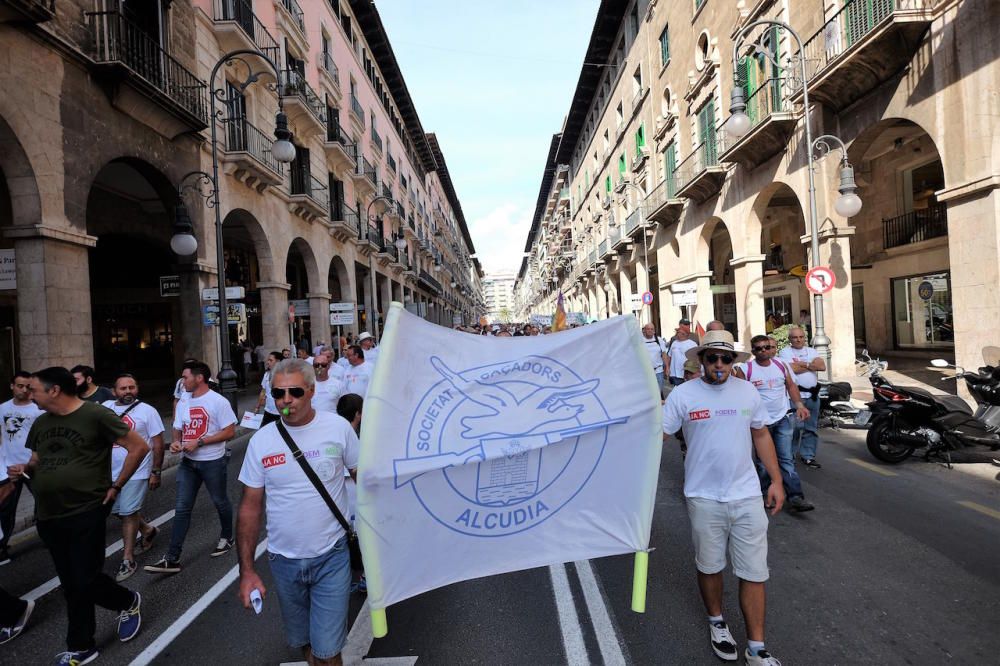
[81,158,182,383]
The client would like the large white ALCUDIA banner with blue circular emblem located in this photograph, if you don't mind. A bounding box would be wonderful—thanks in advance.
[357,303,662,609]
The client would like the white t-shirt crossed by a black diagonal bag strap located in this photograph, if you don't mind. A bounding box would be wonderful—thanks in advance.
[240,412,360,559]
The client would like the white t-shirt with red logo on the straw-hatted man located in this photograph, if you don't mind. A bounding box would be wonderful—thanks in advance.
[663,379,768,502]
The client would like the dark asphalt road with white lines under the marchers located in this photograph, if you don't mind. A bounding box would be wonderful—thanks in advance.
[0,431,1000,664]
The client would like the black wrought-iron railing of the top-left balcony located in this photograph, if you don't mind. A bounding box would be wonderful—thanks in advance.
[87,11,208,125]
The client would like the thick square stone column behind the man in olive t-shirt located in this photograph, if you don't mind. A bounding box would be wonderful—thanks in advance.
[5,227,97,371]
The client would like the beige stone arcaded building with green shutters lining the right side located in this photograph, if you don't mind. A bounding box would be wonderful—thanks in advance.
[515,0,1000,375]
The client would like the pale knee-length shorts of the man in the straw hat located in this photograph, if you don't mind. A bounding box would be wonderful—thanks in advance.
[687,497,768,583]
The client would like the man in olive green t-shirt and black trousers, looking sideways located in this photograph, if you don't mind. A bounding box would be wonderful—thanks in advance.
[7,367,149,663]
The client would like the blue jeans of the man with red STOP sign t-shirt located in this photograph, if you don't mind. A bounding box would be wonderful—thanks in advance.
[167,456,233,562]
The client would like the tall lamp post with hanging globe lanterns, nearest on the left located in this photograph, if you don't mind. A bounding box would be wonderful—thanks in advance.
[176,49,295,412]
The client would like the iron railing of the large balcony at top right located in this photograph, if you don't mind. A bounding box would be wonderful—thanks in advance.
[802,0,940,76]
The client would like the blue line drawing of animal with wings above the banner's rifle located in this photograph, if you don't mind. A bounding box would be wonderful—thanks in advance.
[431,356,601,439]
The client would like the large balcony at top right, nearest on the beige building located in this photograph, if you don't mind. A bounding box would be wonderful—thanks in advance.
[792,0,942,110]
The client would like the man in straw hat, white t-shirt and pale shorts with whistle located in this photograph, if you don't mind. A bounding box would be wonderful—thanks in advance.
[663,331,785,666]
